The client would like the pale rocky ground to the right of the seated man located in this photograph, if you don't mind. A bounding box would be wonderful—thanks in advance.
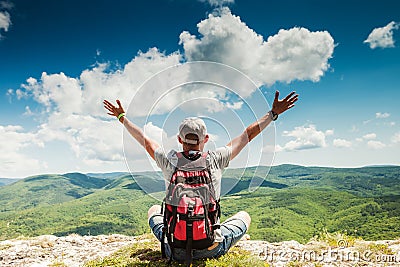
[237,240,400,267]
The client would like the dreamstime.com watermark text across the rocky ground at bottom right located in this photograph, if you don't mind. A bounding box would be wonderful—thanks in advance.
[256,240,400,265]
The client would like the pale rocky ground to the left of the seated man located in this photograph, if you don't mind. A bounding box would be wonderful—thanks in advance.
[0,235,141,267]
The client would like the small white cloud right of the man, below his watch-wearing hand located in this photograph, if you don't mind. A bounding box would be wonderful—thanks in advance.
[279,125,327,151]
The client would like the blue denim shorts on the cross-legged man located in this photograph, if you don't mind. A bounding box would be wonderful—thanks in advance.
[149,213,247,261]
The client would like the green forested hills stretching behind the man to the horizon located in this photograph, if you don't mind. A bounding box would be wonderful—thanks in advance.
[0,165,400,242]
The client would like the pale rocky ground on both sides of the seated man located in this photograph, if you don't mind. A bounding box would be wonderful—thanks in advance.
[0,235,400,267]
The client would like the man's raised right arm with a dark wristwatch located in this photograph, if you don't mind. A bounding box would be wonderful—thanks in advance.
[227,91,299,160]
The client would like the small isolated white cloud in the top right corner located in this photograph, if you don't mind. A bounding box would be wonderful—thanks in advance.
[364,21,399,49]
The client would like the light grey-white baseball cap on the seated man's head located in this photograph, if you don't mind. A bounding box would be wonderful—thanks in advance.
[179,117,207,145]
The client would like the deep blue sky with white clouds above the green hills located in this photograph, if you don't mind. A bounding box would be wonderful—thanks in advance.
[0,0,400,177]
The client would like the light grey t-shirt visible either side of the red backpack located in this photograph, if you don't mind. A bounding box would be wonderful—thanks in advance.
[154,146,232,242]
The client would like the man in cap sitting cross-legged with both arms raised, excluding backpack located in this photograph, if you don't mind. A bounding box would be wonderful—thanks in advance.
[103,91,298,261]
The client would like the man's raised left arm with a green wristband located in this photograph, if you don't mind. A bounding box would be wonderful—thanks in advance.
[103,100,160,159]
